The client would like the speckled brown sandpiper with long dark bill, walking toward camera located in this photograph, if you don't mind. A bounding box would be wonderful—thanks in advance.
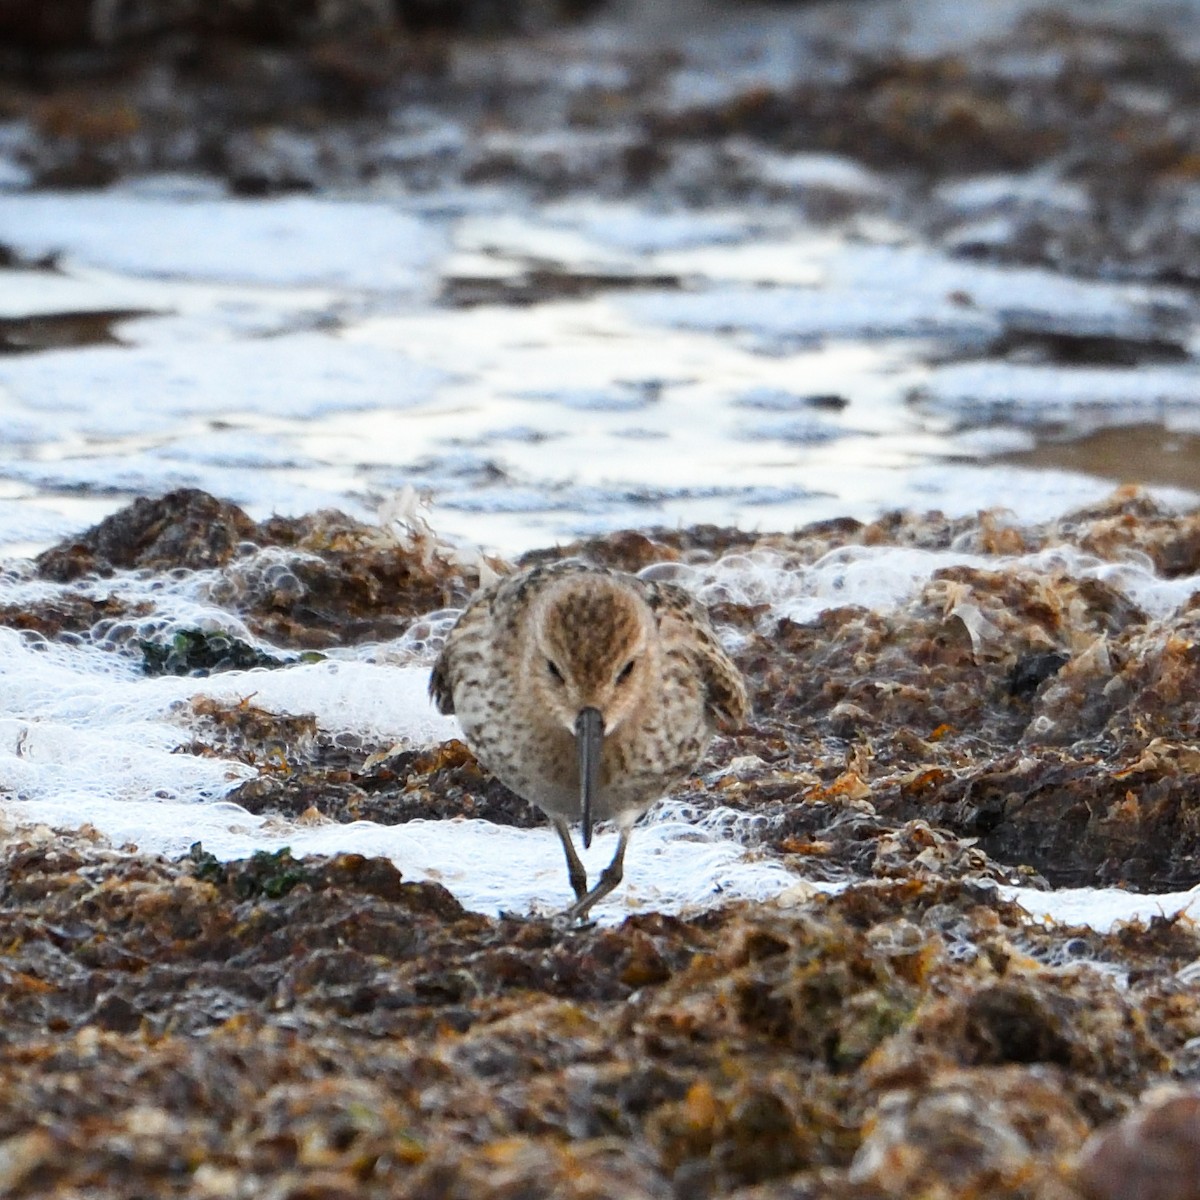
[430,559,748,920]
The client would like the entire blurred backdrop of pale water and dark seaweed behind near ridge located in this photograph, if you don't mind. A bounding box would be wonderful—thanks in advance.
[0,0,1200,553]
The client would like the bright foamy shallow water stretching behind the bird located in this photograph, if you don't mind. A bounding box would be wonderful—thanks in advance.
[0,181,1200,553]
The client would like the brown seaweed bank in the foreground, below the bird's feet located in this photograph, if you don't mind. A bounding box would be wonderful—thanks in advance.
[0,830,1200,1200]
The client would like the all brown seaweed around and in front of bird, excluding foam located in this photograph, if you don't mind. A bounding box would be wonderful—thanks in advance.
[0,491,1200,1200]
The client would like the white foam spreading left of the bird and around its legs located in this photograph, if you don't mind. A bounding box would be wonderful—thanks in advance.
[0,574,793,920]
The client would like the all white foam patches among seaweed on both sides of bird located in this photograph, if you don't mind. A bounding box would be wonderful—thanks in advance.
[0,547,1200,928]
